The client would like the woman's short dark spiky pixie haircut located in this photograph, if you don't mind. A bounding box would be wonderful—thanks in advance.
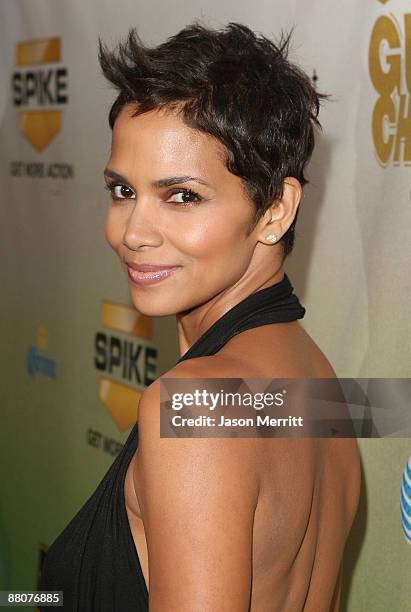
[99,21,328,259]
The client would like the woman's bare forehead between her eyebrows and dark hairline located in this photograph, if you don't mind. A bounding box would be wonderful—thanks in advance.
[110,105,229,173]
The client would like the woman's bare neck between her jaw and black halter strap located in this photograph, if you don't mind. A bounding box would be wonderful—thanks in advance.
[176,265,284,356]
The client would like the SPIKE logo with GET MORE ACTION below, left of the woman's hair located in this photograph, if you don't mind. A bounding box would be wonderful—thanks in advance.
[11,37,73,178]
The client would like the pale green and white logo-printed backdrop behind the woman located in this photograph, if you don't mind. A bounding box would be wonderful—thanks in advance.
[0,0,411,612]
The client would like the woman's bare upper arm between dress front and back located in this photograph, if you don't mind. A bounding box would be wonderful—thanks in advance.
[134,379,259,612]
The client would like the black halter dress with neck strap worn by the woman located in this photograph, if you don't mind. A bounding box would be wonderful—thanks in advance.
[40,274,305,612]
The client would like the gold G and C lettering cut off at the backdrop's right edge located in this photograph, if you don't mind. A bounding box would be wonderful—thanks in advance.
[368,5,411,167]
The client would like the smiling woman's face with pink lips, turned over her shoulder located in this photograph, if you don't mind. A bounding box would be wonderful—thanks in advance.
[105,106,262,316]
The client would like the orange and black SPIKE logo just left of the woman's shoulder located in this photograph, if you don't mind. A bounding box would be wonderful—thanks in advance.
[94,301,157,432]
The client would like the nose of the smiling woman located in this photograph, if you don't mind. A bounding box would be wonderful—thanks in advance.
[123,197,163,251]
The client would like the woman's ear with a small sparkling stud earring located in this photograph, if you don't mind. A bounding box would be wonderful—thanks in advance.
[258,176,302,244]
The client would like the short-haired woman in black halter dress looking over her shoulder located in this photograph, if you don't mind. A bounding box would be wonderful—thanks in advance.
[42,23,360,612]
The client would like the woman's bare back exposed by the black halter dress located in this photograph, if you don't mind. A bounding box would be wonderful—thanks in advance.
[125,322,360,612]
